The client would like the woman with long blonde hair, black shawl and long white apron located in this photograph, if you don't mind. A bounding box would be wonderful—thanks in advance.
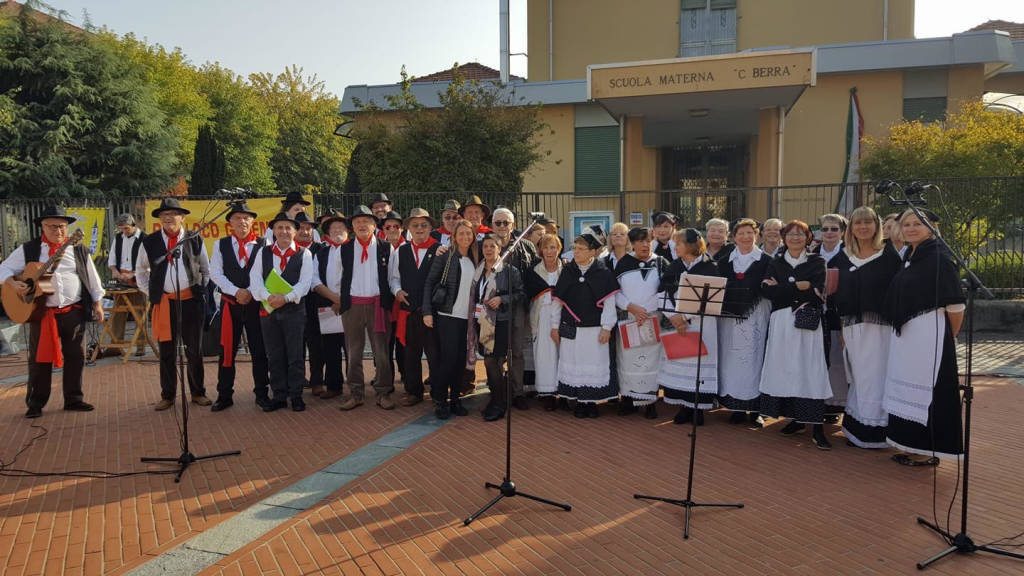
[828,206,900,448]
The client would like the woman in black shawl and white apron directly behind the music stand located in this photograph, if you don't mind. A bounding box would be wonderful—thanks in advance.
[657,228,719,425]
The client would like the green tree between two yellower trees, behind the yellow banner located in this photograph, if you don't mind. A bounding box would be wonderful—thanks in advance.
[199,63,278,194]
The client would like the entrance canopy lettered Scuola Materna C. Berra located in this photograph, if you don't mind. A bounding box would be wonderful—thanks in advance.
[587,49,815,147]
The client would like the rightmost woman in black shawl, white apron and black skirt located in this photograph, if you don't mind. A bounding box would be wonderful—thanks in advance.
[885,210,965,465]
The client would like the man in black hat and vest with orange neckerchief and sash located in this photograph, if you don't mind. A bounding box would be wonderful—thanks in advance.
[135,198,212,410]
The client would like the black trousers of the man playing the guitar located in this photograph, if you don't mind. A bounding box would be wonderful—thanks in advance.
[25,307,90,408]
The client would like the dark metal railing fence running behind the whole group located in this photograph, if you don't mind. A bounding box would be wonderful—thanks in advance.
[0,176,1024,297]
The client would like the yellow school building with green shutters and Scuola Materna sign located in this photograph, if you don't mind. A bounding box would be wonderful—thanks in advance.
[341,0,1024,228]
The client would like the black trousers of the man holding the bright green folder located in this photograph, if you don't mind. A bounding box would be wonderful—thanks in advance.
[260,303,306,400]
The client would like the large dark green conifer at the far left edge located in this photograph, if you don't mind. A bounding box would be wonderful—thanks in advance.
[0,2,176,197]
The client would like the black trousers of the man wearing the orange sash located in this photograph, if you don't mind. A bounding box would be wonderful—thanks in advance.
[160,296,206,400]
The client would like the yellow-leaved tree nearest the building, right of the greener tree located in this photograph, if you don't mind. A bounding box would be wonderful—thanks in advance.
[249,66,353,192]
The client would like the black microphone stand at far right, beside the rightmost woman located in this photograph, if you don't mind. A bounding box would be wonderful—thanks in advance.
[889,183,1024,570]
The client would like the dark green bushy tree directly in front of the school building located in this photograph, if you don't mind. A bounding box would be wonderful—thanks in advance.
[350,65,546,205]
